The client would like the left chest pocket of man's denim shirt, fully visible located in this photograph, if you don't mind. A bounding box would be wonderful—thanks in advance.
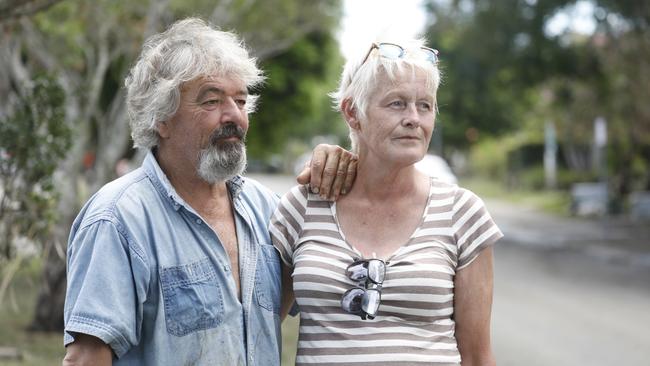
[160,258,224,337]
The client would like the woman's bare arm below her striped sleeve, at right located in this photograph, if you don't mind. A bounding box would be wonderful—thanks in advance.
[454,246,496,366]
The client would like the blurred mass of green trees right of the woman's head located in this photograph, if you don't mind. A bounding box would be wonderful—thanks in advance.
[427,0,650,199]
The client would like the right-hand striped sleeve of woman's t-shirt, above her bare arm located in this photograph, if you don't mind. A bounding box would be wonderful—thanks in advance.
[453,188,503,270]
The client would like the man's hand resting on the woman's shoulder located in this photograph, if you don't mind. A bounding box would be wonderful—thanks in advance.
[296,144,357,201]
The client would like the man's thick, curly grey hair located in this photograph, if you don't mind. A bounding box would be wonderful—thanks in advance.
[125,18,264,149]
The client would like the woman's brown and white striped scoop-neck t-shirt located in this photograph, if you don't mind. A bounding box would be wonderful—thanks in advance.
[270,179,503,366]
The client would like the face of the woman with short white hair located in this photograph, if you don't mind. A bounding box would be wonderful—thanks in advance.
[358,70,436,165]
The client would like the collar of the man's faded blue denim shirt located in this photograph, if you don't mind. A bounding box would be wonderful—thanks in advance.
[142,150,244,211]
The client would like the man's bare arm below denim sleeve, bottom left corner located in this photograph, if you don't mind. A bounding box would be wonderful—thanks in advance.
[63,333,113,366]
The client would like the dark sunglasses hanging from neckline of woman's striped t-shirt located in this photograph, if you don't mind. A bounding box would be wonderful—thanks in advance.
[341,259,386,320]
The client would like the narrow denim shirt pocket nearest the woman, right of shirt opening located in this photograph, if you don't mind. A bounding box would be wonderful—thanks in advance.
[255,244,282,314]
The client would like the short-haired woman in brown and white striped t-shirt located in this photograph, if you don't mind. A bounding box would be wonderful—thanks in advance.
[270,40,502,366]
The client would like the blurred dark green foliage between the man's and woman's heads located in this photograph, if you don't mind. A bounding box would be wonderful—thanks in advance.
[247,32,347,162]
